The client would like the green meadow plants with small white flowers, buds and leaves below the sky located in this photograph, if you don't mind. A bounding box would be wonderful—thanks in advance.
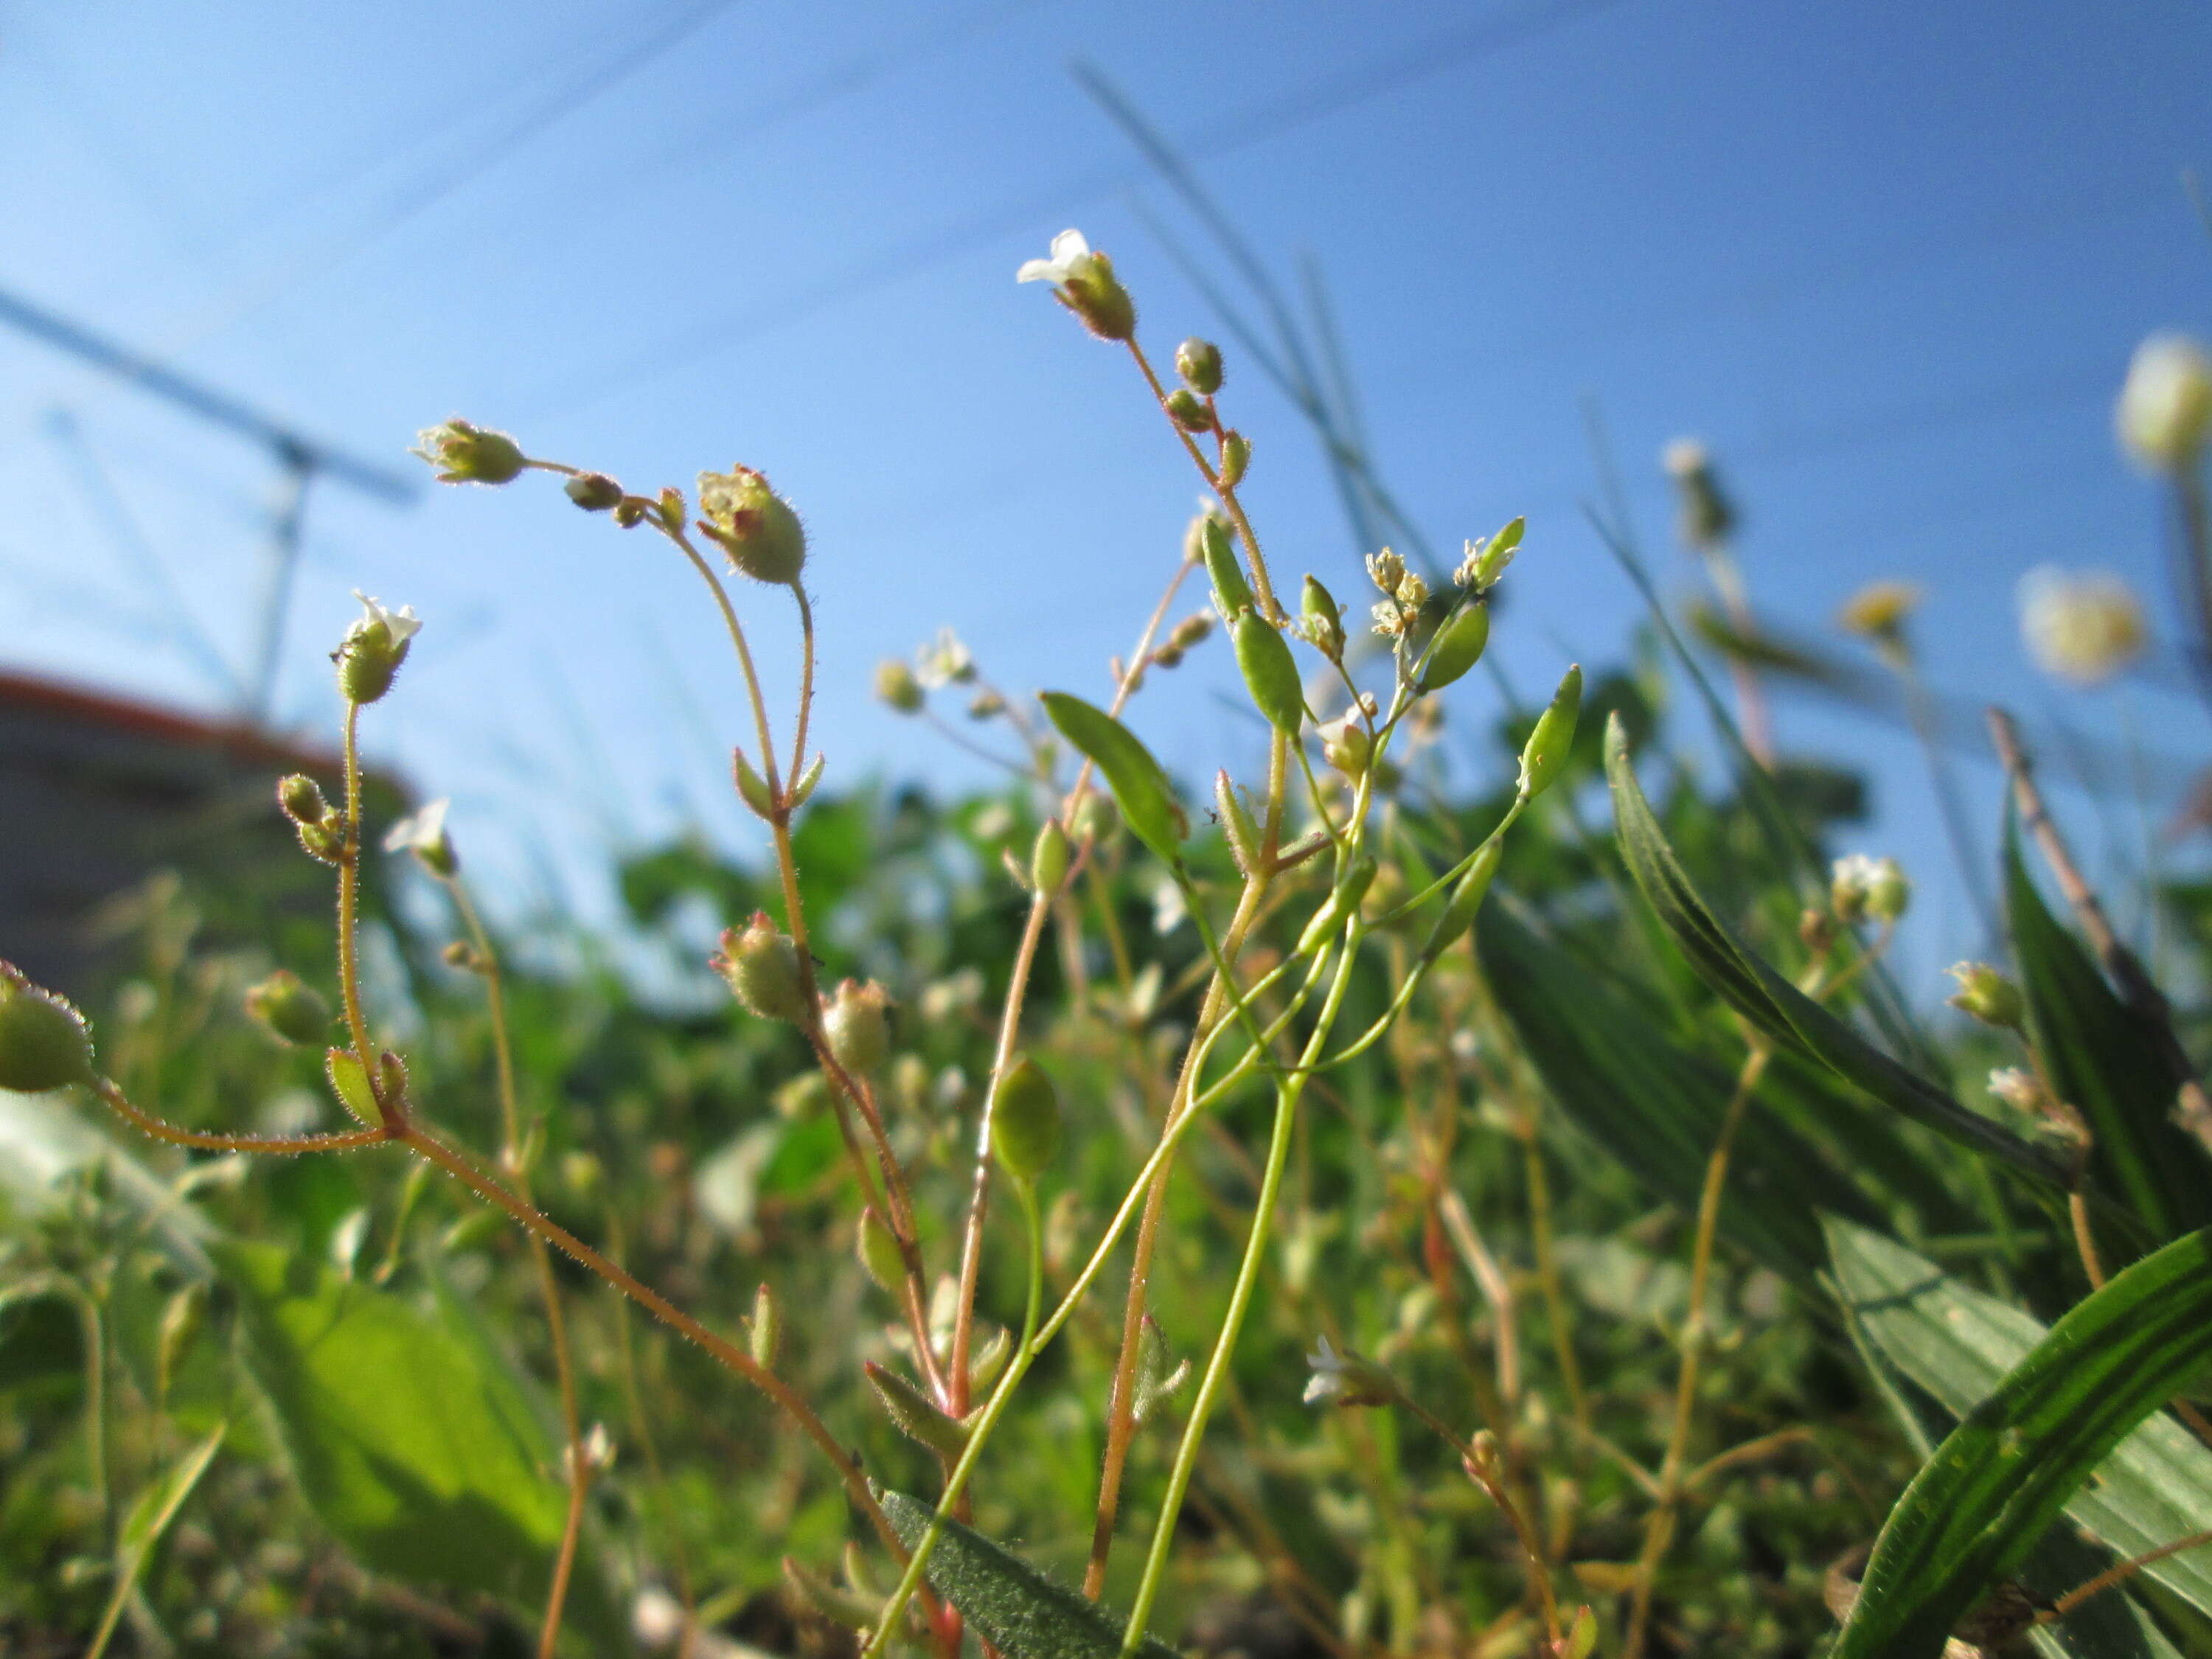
[13,232,2212,1659]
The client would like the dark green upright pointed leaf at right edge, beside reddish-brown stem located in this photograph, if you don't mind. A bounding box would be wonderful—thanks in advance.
[2004,834,2212,1241]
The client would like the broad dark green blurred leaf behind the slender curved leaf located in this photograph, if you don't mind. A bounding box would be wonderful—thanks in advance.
[1475,905,1876,1287]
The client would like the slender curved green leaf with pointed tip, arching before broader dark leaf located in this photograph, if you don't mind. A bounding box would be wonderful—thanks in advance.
[1606,714,2068,1192]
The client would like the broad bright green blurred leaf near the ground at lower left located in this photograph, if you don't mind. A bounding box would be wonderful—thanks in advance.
[219,1243,566,1606]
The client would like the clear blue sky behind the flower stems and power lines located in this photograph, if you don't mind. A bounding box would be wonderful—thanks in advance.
[0,0,2212,993]
